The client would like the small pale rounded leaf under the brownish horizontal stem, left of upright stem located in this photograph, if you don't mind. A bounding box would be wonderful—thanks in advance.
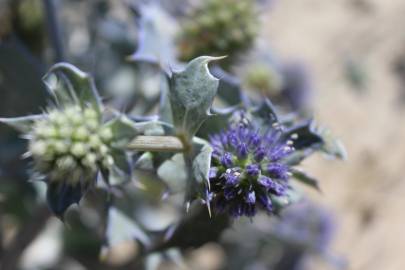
[157,154,187,193]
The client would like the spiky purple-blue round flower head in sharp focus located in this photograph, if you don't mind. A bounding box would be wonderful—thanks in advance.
[209,120,294,217]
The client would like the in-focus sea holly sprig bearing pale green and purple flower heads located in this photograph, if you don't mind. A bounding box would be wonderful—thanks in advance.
[0,53,336,268]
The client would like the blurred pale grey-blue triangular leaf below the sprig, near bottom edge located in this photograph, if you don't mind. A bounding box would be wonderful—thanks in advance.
[106,207,150,247]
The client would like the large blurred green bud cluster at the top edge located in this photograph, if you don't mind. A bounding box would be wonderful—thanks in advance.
[179,0,258,67]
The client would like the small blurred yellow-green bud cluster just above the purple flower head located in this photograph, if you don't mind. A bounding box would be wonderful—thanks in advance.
[243,63,283,98]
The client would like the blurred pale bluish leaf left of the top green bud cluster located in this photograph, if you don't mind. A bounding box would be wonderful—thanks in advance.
[130,4,177,71]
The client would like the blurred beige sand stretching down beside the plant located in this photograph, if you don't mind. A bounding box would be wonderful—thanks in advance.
[263,0,405,270]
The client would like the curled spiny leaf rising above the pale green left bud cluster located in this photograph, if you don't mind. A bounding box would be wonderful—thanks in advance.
[44,63,102,113]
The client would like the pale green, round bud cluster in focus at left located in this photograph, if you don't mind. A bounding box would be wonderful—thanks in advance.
[29,106,114,185]
